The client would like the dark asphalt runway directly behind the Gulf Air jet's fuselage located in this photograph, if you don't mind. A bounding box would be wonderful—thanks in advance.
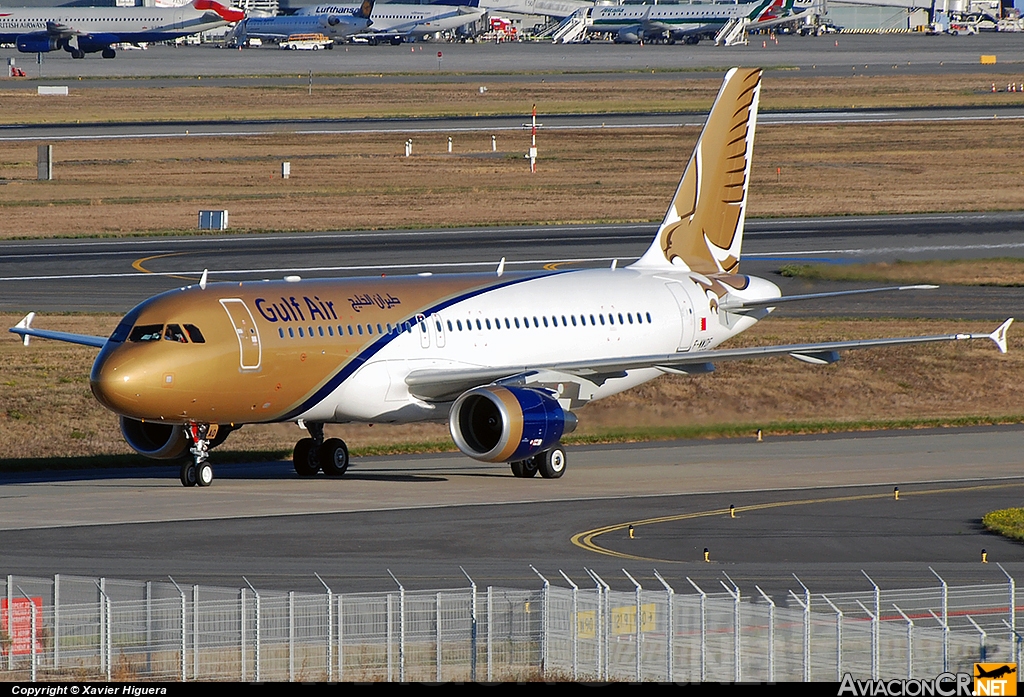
[0,212,1024,317]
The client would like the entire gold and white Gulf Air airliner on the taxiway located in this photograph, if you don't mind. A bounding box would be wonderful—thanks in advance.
[10,69,1012,486]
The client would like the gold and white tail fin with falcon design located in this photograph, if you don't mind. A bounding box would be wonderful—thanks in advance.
[634,68,761,273]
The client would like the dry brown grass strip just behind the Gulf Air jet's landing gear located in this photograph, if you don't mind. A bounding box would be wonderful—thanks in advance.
[0,315,1024,462]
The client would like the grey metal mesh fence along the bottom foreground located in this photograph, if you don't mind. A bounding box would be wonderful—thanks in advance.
[0,573,1021,682]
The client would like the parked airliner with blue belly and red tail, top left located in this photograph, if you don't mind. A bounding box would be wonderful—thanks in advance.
[0,0,245,58]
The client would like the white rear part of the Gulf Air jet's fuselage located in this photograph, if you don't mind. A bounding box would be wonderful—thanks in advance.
[301,267,779,422]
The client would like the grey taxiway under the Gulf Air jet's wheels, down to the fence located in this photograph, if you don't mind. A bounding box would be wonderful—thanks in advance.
[0,427,1024,594]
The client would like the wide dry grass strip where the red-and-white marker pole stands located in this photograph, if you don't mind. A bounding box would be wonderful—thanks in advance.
[6,122,1024,238]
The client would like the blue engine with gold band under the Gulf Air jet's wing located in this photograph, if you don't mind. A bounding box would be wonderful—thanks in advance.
[449,386,577,463]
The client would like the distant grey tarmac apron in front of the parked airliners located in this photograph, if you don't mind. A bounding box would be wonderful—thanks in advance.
[0,33,1024,81]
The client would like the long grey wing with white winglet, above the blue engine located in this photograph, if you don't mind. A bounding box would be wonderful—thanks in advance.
[406,318,1013,401]
